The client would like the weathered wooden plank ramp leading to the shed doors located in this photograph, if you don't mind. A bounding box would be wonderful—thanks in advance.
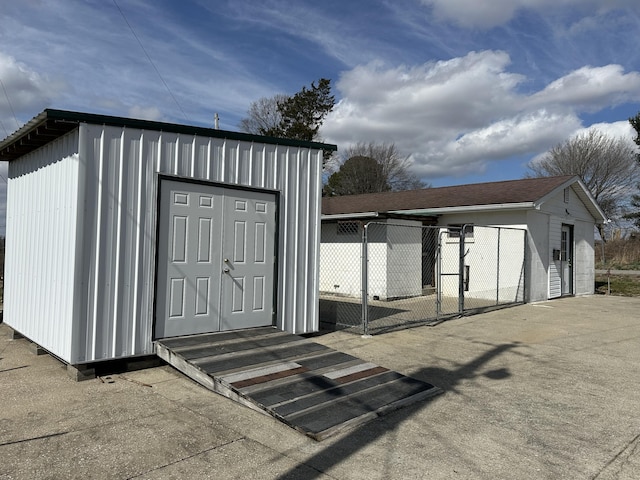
[156,327,442,440]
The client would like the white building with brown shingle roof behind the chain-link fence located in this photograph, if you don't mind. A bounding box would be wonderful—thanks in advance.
[320,176,606,302]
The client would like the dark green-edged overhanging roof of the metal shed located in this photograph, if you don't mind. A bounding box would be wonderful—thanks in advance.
[0,108,338,161]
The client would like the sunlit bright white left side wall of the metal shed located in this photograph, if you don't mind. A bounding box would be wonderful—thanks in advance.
[4,131,79,360]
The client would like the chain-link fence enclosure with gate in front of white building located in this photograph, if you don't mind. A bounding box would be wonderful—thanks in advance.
[320,220,526,334]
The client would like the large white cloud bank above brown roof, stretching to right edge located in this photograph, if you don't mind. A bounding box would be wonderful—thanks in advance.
[322,51,640,179]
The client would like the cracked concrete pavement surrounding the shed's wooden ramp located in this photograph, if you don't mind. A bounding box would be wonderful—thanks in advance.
[0,296,640,480]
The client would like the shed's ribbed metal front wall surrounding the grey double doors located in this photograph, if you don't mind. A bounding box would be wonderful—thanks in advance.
[71,124,322,363]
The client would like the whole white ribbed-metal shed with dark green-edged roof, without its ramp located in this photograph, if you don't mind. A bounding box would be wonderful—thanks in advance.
[0,109,336,364]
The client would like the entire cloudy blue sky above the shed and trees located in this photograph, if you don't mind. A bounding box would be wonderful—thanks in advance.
[0,0,640,232]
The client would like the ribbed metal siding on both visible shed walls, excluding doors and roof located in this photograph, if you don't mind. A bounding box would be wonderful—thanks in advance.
[5,123,322,364]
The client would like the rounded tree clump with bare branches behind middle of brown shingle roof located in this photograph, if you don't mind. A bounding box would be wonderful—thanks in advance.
[324,142,430,195]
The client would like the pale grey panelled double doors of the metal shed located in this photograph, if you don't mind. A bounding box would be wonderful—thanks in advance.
[155,180,276,338]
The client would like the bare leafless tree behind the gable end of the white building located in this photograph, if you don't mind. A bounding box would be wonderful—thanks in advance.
[527,129,640,238]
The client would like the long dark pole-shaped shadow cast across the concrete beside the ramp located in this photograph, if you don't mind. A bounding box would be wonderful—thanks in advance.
[278,343,520,480]
